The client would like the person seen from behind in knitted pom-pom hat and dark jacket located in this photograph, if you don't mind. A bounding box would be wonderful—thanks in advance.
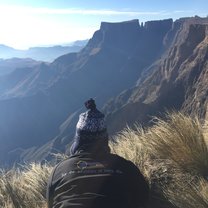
[47,99,149,208]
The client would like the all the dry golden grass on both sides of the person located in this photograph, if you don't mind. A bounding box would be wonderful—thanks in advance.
[0,113,208,208]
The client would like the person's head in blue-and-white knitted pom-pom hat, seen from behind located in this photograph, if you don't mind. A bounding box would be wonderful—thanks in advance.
[71,98,110,154]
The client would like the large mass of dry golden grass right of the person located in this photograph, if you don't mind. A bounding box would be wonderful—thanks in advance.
[111,113,208,208]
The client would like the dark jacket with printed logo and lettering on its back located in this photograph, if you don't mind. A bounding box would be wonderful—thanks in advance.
[47,153,149,208]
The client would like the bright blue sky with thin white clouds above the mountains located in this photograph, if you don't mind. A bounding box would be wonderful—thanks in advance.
[0,0,208,49]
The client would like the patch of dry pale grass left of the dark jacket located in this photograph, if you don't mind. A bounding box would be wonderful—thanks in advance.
[0,163,52,208]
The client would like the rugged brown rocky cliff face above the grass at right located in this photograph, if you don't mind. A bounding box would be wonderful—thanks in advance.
[105,18,208,132]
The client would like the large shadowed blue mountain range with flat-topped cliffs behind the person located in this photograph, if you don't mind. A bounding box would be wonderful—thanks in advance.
[0,16,208,165]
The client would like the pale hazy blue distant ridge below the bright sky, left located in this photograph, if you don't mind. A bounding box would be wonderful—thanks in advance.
[0,40,88,62]
